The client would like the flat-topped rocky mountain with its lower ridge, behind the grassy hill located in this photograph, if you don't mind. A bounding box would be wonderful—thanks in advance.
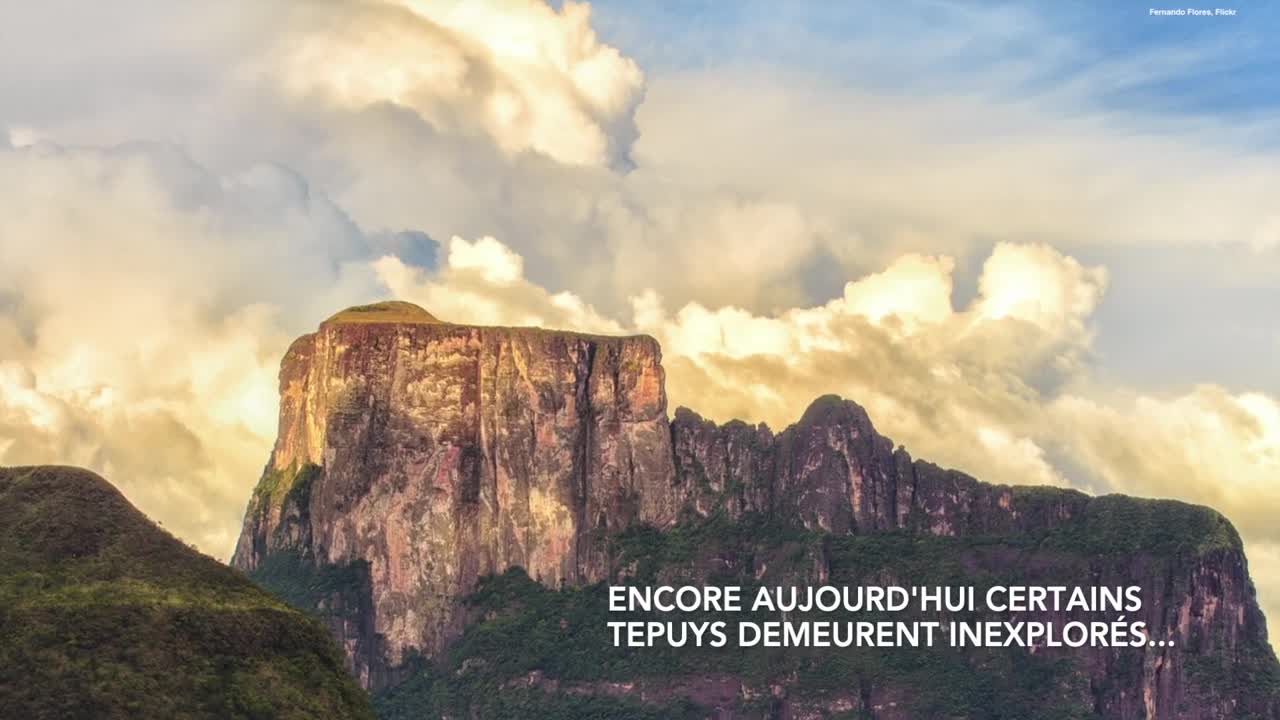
[233,304,1280,719]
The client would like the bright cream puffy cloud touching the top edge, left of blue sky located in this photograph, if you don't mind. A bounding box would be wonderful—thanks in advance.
[276,0,644,167]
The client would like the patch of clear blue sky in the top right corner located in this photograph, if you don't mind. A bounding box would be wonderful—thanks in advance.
[593,0,1280,122]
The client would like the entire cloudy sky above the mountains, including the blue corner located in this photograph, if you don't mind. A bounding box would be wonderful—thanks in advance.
[0,0,1280,638]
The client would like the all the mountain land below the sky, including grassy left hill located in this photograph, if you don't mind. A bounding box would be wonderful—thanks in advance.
[0,302,1280,720]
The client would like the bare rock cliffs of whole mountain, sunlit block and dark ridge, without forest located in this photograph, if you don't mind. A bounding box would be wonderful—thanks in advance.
[233,304,1276,719]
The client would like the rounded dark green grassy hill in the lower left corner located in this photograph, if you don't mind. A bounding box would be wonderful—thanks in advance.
[0,466,372,720]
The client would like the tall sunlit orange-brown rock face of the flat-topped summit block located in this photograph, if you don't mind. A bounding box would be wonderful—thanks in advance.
[232,303,676,685]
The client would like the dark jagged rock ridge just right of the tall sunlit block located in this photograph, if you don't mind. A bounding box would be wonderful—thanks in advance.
[671,396,1088,536]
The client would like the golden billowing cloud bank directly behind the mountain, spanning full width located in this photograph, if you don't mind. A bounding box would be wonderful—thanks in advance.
[0,143,1280,645]
